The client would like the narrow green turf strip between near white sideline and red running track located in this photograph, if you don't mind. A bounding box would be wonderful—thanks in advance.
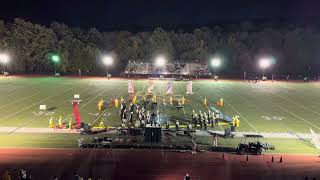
[0,133,320,154]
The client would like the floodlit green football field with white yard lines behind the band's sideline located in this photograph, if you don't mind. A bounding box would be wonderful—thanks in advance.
[0,77,320,133]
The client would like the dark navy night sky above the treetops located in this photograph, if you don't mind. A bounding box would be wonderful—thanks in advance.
[0,0,320,30]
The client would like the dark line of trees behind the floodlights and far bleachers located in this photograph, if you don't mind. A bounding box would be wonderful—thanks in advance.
[0,18,320,73]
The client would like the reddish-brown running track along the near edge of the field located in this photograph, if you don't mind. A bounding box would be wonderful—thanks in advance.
[0,148,320,180]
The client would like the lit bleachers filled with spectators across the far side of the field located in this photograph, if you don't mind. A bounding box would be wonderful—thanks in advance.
[124,60,209,76]
